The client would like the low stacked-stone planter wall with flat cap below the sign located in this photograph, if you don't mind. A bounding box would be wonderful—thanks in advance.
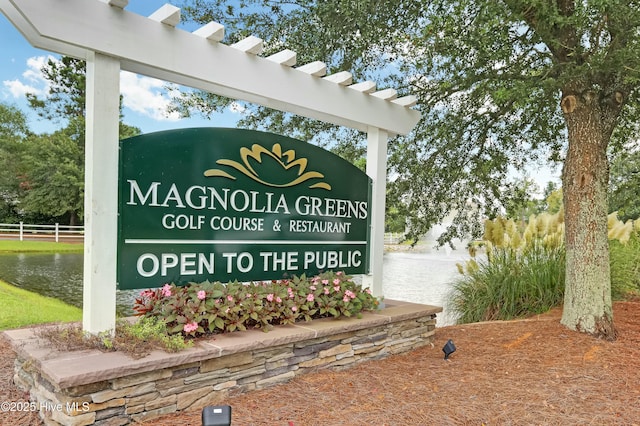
[5,301,442,425]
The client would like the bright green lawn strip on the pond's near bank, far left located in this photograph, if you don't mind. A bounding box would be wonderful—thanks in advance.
[0,281,82,331]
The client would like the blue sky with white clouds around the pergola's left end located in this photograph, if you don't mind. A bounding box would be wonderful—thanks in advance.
[0,0,240,133]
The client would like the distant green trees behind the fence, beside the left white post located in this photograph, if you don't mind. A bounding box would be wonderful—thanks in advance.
[0,56,140,225]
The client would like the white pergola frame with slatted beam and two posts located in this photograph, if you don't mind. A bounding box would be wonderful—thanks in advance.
[0,0,420,333]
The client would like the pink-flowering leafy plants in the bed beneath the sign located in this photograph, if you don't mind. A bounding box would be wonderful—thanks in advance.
[133,272,379,337]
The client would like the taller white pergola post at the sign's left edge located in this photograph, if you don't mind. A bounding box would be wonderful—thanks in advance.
[82,52,120,334]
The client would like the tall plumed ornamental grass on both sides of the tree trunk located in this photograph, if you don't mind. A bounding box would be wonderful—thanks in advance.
[448,211,640,322]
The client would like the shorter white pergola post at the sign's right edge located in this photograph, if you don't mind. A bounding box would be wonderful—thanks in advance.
[367,127,388,297]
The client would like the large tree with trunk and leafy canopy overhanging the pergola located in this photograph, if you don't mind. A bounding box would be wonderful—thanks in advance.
[180,0,640,339]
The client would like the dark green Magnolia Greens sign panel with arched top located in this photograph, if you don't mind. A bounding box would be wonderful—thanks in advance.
[118,128,371,289]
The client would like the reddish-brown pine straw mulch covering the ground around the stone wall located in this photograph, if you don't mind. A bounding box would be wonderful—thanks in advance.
[0,301,640,426]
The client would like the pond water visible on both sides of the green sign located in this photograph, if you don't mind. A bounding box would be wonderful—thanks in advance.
[0,249,469,326]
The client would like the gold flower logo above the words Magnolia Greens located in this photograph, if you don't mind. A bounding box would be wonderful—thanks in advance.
[204,143,331,190]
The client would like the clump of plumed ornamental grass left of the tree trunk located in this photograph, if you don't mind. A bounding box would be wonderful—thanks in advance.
[448,213,565,323]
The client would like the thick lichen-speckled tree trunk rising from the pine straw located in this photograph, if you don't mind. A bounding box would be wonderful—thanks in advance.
[561,91,616,340]
